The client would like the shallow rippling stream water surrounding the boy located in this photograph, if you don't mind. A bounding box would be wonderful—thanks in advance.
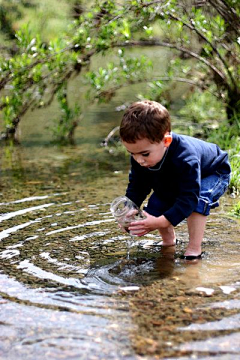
[0,100,240,360]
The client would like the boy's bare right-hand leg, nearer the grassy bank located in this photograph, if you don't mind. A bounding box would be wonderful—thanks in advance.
[185,212,207,256]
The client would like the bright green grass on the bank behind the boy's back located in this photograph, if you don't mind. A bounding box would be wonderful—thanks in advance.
[176,92,240,196]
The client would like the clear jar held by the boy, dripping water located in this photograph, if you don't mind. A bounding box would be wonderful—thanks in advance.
[110,196,146,232]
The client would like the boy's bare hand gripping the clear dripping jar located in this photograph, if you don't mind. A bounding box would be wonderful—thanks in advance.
[128,211,171,236]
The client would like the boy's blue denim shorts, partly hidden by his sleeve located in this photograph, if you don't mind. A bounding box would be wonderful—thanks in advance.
[144,172,230,216]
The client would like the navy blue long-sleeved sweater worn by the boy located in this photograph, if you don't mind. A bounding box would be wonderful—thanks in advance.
[126,133,231,226]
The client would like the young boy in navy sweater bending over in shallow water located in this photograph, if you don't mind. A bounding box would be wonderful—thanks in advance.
[120,100,231,260]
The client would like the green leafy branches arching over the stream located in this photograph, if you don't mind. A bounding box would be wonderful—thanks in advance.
[0,0,240,141]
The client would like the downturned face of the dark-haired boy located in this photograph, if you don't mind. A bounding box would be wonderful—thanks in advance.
[122,138,170,168]
